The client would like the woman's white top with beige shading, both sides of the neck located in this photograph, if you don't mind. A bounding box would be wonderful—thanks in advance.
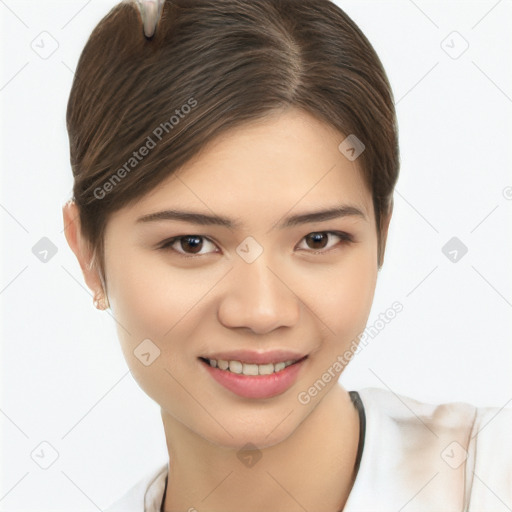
[105,388,512,512]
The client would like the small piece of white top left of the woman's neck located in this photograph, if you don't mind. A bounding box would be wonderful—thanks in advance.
[105,463,168,512]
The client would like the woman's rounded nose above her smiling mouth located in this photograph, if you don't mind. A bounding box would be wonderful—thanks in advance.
[218,252,301,334]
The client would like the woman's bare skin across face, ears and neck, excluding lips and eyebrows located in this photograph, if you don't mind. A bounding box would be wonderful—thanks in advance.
[63,108,391,512]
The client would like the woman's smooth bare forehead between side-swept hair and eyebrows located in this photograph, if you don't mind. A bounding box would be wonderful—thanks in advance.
[120,109,373,226]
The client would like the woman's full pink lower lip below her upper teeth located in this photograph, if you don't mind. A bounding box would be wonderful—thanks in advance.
[200,358,306,398]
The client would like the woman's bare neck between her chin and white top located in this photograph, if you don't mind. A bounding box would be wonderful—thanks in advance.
[162,385,359,512]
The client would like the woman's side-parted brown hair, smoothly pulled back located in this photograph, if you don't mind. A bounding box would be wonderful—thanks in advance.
[67,0,399,288]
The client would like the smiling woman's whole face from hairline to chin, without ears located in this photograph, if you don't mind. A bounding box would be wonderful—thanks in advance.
[99,109,378,447]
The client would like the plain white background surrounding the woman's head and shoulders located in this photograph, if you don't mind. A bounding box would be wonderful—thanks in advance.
[0,0,512,512]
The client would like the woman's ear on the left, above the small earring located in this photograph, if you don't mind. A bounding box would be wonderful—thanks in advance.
[62,200,103,295]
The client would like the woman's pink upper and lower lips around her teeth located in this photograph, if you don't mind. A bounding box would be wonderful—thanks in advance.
[201,351,307,398]
